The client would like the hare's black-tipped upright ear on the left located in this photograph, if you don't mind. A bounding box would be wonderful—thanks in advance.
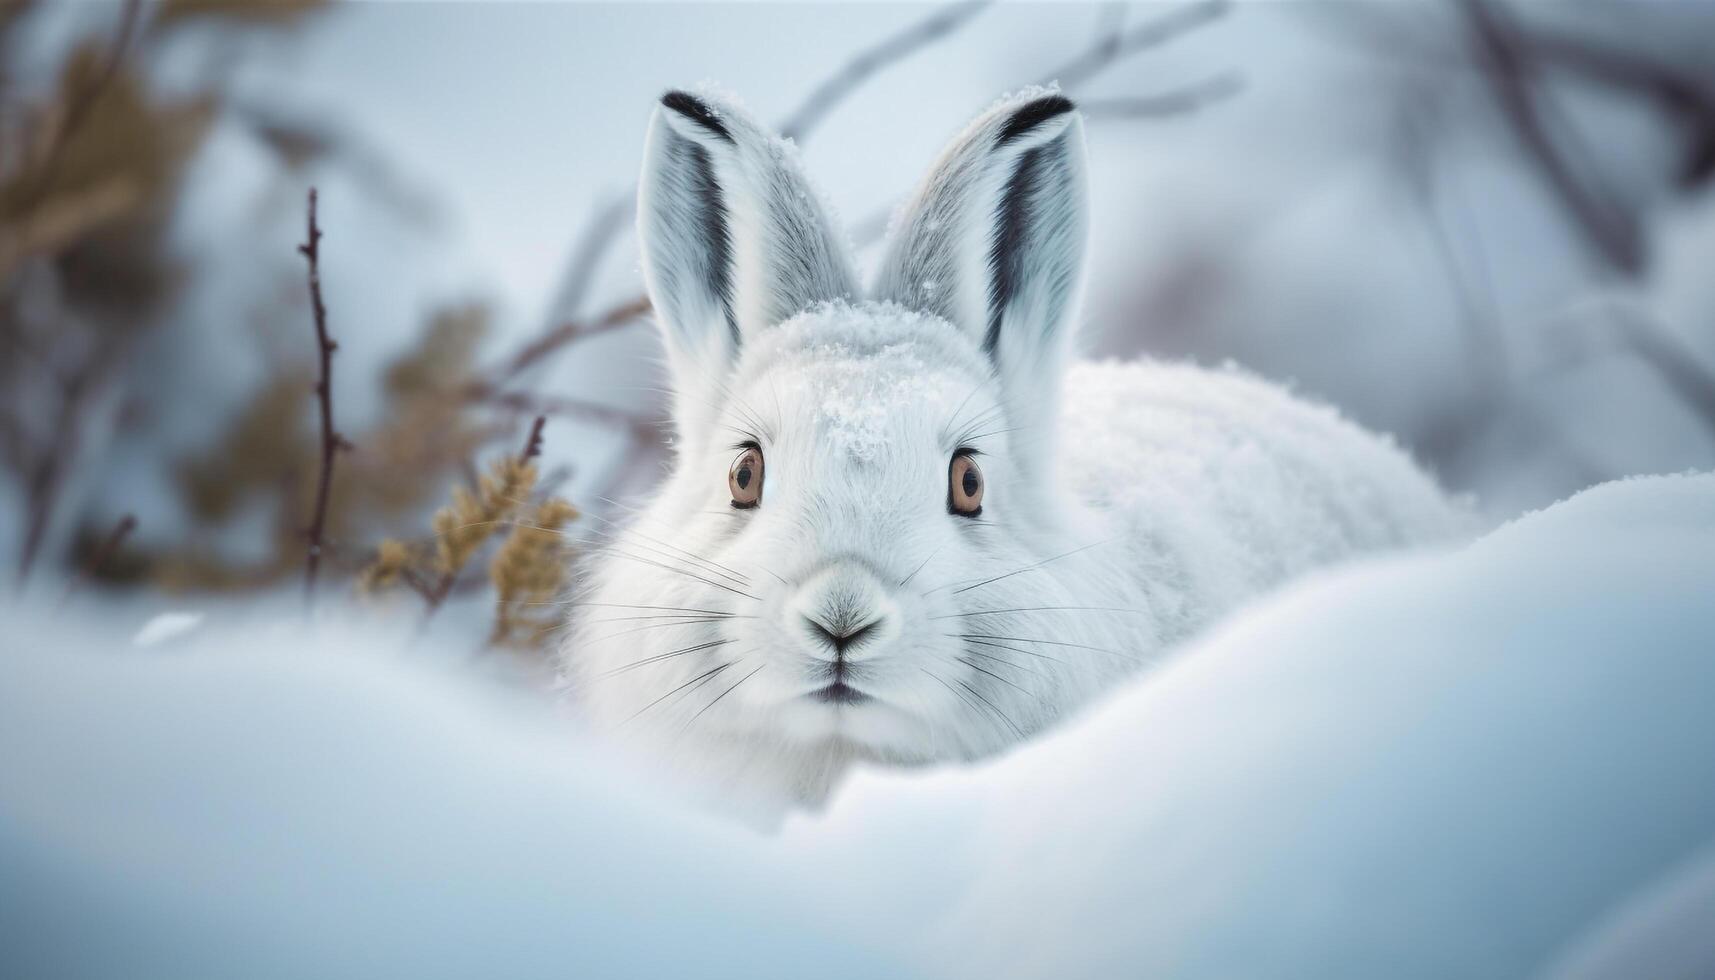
[638,91,856,437]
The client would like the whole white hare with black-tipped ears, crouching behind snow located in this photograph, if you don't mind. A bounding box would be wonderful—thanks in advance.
[563,91,1461,813]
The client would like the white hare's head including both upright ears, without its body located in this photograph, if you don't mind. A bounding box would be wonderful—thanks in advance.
[566,93,1101,760]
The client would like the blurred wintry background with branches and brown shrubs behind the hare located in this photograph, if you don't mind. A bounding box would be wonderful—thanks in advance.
[0,0,1715,650]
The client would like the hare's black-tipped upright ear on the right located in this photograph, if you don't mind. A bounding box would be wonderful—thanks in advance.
[876,94,1086,425]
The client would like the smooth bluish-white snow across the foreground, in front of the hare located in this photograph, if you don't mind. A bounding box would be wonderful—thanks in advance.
[0,475,1715,980]
